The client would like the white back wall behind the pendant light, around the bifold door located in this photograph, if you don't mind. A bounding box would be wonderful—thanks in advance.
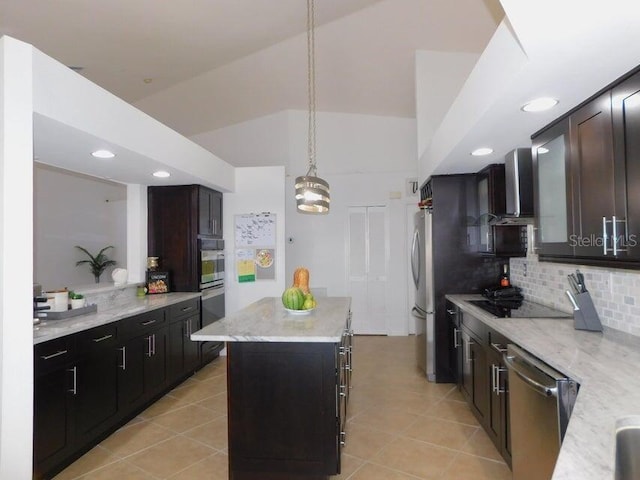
[192,110,417,334]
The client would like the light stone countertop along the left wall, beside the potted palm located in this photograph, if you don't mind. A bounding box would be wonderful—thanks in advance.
[33,292,200,345]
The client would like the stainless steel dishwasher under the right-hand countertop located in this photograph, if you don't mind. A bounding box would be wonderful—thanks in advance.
[504,344,578,480]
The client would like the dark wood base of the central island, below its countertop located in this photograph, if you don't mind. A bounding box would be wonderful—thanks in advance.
[227,315,352,480]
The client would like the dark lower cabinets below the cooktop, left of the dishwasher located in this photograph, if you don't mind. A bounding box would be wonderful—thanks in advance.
[447,304,511,465]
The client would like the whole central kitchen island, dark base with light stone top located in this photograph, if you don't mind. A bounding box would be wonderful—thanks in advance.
[191,297,351,480]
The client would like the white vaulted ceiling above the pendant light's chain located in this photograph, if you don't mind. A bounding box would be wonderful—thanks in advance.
[0,0,503,153]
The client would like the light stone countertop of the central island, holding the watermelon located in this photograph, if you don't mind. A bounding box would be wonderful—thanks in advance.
[191,297,351,343]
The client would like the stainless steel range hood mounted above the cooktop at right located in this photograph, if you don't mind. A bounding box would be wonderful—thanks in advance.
[491,148,533,225]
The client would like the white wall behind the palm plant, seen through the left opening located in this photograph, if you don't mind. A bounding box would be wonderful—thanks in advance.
[33,164,126,290]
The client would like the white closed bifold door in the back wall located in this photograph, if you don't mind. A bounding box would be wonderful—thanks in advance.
[348,206,389,335]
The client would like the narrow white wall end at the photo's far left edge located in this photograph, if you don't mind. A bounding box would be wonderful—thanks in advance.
[0,37,33,479]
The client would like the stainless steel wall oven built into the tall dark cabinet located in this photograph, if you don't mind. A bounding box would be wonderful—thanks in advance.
[198,238,225,364]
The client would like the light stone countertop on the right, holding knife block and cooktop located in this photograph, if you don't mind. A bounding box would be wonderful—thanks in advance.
[447,295,640,480]
